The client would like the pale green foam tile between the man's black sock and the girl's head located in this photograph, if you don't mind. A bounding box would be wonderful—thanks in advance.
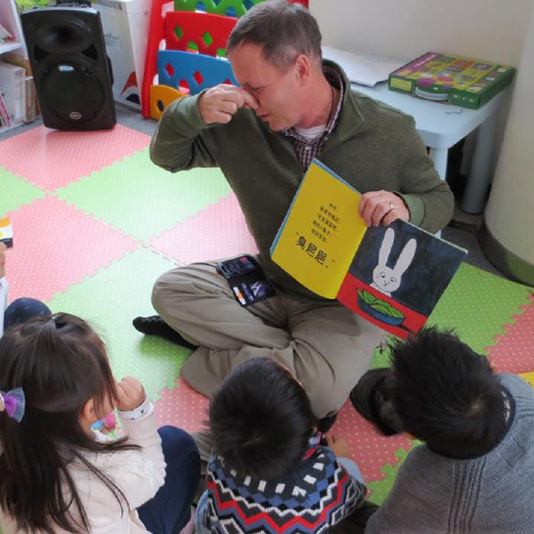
[48,247,191,400]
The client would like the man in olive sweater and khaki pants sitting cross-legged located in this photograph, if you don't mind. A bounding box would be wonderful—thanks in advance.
[134,0,453,428]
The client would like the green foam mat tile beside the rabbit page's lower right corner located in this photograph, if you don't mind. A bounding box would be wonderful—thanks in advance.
[428,263,532,353]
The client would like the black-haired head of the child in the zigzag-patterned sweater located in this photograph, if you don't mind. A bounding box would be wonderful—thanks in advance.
[209,358,317,480]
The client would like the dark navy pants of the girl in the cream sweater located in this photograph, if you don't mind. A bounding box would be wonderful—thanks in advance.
[137,426,200,534]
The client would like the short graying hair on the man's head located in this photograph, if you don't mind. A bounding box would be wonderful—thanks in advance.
[226,0,322,71]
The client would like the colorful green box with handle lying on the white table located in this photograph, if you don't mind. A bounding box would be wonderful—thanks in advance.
[388,52,515,109]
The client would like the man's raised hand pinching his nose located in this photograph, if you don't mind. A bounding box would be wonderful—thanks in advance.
[198,84,258,124]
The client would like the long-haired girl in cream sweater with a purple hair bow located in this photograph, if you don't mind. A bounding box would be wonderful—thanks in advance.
[0,314,200,534]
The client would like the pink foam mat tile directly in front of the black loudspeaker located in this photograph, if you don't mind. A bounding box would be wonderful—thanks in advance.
[0,124,150,191]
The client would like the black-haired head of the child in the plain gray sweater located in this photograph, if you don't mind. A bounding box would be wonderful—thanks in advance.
[388,328,506,458]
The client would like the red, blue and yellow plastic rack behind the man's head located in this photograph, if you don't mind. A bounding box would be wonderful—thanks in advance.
[141,0,308,119]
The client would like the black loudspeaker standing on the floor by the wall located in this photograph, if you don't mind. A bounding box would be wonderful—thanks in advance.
[21,7,116,131]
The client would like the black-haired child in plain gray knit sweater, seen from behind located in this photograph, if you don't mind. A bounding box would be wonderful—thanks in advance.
[353,329,534,534]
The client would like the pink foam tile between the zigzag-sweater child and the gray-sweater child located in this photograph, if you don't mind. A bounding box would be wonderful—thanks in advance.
[331,400,412,482]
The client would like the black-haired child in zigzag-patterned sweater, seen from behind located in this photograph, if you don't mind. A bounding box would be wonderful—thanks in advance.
[197,358,366,534]
